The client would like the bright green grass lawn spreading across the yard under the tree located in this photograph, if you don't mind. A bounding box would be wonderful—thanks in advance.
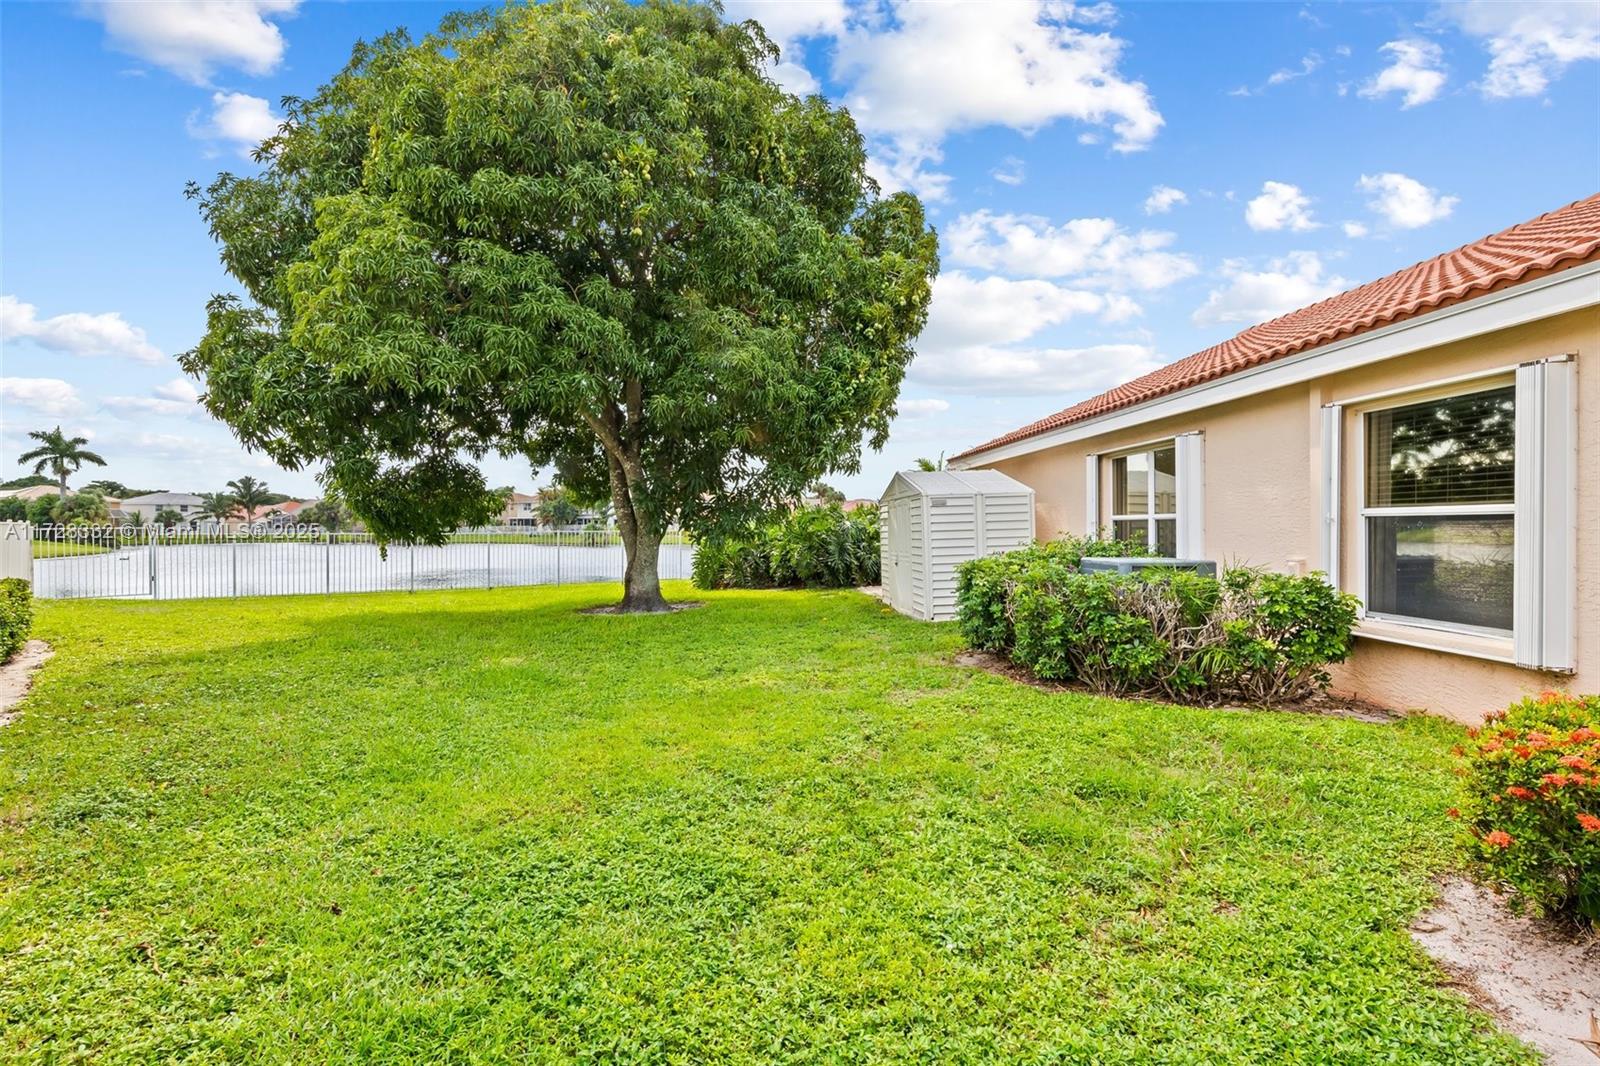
[0,584,1534,1063]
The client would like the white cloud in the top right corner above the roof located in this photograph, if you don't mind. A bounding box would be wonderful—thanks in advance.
[1440,0,1600,99]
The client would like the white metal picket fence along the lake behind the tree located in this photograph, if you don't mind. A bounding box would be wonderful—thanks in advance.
[34,525,694,600]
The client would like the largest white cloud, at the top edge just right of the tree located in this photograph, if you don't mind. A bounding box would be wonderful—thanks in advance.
[832,0,1163,198]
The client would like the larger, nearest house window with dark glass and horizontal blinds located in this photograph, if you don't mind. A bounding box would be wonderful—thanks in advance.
[1362,384,1517,632]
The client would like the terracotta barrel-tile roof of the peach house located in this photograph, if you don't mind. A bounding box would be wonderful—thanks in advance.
[955,194,1600,459]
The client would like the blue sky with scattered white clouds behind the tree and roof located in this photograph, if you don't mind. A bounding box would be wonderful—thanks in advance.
[0,0,1600,496]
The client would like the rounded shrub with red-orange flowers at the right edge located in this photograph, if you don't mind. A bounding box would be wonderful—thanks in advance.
[1453,691,1600,924]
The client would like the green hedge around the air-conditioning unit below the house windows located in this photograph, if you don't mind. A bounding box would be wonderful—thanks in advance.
[957,541,1355,704]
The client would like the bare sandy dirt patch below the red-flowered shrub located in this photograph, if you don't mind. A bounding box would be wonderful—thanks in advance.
[1411,876,1600,1066]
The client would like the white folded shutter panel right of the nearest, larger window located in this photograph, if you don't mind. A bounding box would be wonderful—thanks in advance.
[1512,355,1578,671]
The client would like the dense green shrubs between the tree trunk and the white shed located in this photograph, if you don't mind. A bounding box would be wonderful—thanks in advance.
[694,504,880,589]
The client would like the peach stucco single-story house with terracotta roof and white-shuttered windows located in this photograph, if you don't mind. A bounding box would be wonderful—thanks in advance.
[950,195,1600,720]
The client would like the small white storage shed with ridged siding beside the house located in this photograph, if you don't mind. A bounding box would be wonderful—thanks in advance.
[878,471,1034,621]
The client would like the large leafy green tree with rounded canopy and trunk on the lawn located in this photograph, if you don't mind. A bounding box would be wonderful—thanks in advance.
[182,0,938,610]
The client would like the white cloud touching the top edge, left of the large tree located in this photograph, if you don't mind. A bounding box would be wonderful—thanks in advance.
[83,0,299,85]
